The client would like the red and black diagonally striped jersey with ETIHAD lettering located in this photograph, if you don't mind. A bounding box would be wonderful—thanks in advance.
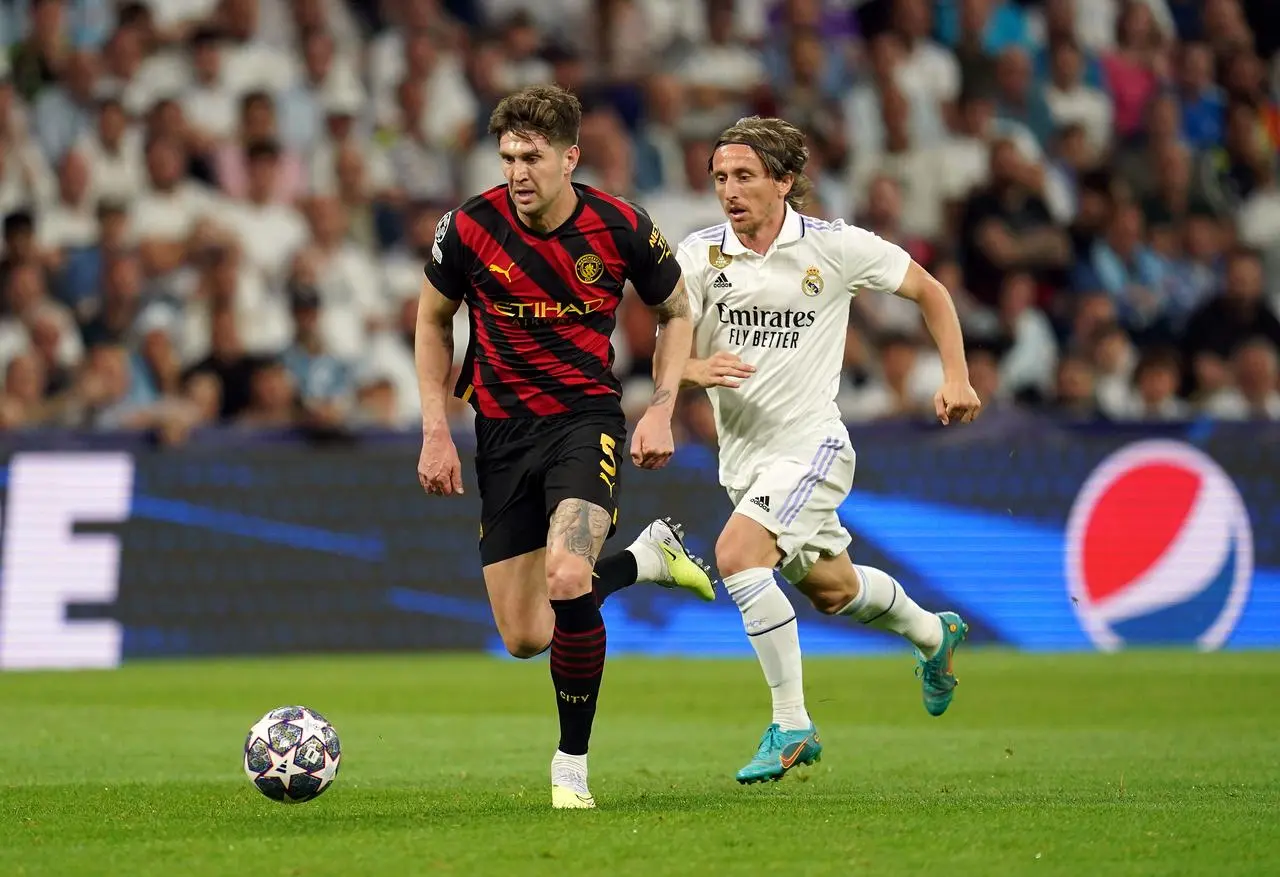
[426,183,680,417]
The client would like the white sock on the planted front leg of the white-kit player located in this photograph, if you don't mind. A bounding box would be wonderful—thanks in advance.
[724,567,812,731]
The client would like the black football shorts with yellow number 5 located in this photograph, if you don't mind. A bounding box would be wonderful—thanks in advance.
[476,410,627,566]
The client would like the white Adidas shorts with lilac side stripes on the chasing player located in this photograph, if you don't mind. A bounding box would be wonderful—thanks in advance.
[728,435,856,584]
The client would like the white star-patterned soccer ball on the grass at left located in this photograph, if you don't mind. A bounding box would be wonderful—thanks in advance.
[244,707,342,804]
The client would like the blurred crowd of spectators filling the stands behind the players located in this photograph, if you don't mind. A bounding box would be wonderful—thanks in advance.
[0,0,1280,443]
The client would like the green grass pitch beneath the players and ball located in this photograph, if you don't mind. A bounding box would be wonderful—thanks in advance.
[0,649,1280,877]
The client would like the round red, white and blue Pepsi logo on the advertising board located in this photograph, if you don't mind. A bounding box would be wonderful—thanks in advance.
[1066,440,1253,650]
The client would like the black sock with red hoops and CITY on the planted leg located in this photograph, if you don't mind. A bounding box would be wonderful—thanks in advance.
[550,594,604,755]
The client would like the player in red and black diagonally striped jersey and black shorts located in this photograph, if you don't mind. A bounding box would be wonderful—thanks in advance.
[415,86,714,809]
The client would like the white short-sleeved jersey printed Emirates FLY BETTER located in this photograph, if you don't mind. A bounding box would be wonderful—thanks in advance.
[676,206,911,489]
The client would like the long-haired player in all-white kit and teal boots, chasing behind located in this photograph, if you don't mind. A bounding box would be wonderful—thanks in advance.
[676,117,982,782]
